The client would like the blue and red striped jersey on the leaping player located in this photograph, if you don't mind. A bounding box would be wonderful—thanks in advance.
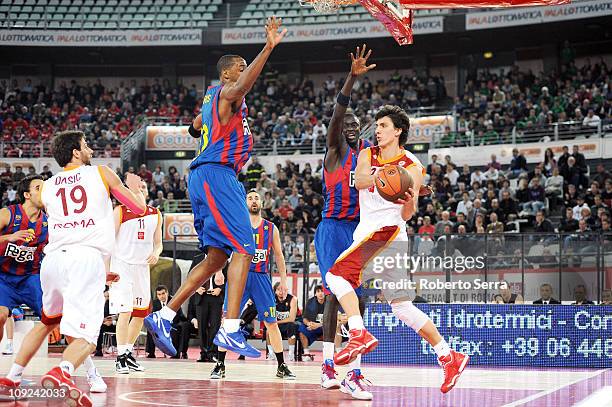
[190,85,253,174]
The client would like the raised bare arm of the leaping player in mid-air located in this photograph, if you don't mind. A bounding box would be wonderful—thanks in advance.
[219,16,287,104]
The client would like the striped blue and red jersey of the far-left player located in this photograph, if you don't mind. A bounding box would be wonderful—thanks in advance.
[0,205,49,276]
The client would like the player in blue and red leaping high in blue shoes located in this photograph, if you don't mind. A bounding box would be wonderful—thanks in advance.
[145,17,287,357]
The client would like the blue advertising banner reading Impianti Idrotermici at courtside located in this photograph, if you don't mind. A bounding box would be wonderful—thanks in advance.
[364,304,612,367]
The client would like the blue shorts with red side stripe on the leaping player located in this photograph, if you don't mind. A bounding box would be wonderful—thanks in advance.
[188,164,255,256]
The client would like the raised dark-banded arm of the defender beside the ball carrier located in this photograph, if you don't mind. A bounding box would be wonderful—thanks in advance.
[326,44,376,157]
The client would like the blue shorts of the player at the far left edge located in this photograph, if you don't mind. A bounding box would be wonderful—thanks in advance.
[0,273,42,317]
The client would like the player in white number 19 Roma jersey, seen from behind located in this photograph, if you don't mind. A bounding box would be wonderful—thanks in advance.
[0,131,146,406]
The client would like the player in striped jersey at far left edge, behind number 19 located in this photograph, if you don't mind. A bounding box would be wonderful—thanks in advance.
[0,175,48,340]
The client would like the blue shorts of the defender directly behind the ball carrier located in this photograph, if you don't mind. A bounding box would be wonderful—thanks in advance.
[315,218,359,294]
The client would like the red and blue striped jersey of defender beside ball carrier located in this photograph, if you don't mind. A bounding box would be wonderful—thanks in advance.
[322,140,371,220]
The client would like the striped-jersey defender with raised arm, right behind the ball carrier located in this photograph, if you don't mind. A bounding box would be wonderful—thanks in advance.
[315,44,376,399]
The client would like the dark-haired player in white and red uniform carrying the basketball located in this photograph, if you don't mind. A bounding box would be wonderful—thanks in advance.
[327,105,469,393]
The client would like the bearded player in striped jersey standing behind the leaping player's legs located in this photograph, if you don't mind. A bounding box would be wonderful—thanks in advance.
[210,189,295,380]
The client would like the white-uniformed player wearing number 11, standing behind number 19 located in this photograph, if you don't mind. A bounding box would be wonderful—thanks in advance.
[109,182,163,374]
